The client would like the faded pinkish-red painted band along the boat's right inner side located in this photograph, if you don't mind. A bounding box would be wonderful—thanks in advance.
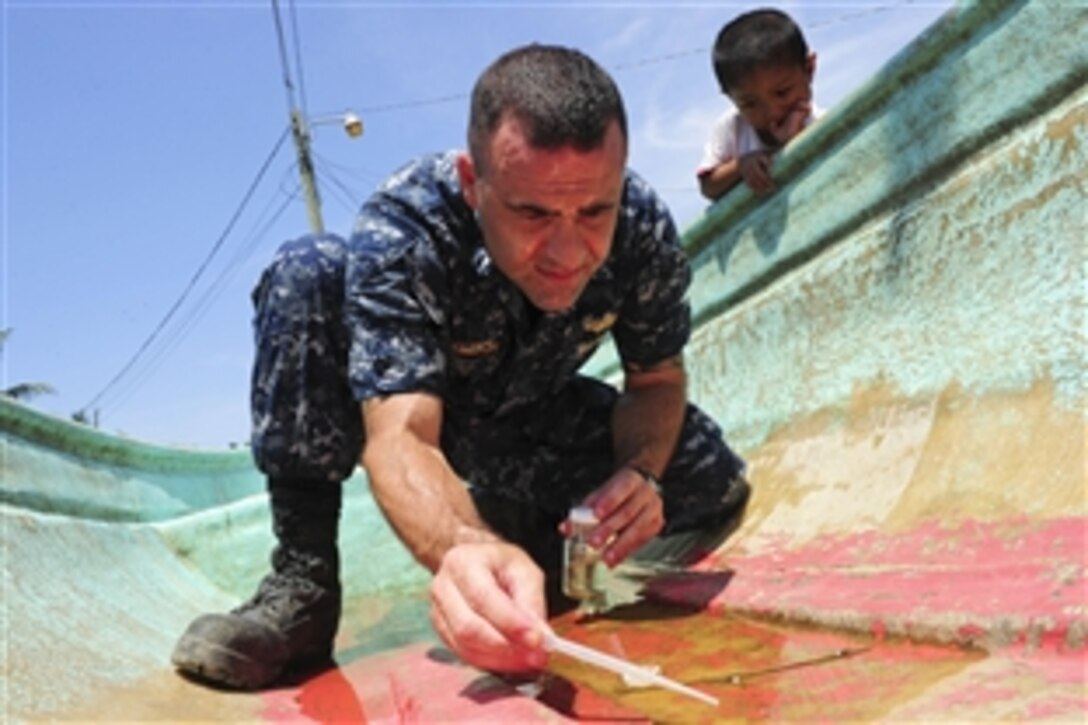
[674,518,1088,652]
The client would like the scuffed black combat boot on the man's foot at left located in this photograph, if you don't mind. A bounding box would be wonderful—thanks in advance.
[171,479,341,690]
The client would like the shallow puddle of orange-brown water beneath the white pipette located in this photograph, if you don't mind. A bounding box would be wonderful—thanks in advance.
[544,605,982,723]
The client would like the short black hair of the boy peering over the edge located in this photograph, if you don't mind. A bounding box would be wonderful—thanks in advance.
[713,9,808,95]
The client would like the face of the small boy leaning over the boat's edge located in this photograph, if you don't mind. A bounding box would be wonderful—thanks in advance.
[729,53,816,146]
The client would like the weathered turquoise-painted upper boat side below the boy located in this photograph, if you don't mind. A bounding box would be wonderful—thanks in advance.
[687,1,1088,444]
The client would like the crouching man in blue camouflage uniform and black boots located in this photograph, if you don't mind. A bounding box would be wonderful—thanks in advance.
[174,46,747,688]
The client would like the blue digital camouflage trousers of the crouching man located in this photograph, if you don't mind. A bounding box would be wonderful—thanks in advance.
[251,235,744,555]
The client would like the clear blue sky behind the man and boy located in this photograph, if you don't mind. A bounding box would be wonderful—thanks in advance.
[0,0,953,447]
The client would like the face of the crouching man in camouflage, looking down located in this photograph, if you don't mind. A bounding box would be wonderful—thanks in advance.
[458,118,627,312]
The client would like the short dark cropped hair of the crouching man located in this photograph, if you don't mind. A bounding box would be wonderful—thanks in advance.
[469,44,627,171]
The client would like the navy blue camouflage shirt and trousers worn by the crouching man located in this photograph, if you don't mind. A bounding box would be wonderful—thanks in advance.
[252,152,744,568]
